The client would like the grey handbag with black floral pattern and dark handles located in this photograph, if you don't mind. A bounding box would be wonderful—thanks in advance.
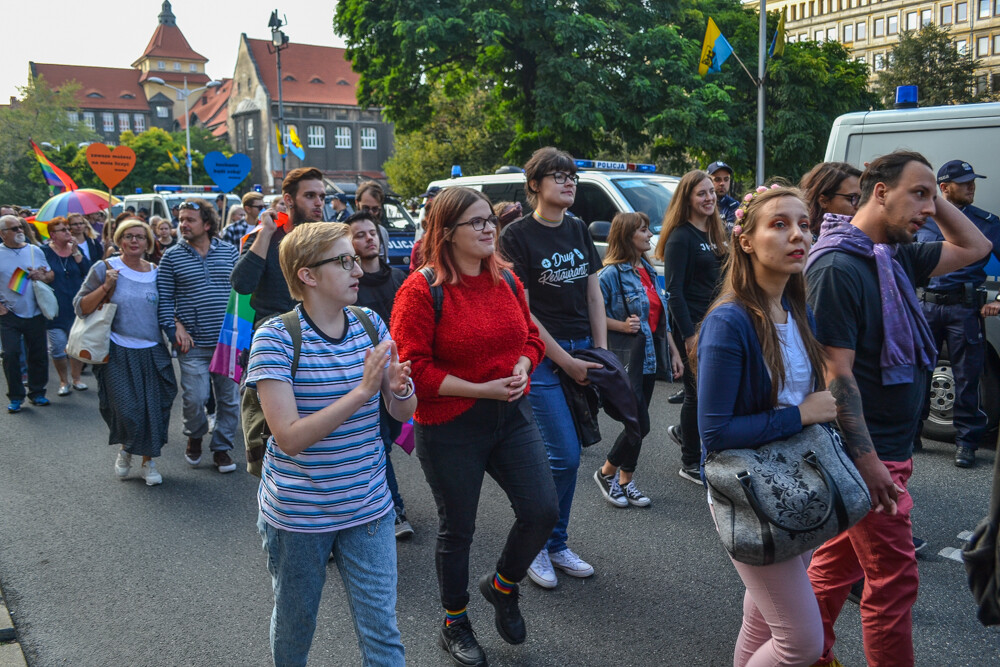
[705,424,871,565]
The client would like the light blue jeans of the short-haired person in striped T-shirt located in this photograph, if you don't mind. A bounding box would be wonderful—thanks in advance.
[257,512,405,667]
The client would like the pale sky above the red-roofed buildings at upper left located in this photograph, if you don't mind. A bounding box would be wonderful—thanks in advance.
[0,0,344,104]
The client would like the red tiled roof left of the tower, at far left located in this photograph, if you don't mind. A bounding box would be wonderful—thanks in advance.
[29,63,149,111]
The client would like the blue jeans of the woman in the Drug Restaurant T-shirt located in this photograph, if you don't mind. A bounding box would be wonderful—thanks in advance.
[528,337,594,553]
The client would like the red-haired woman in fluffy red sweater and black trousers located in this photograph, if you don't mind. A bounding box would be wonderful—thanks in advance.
[392,187,559,665]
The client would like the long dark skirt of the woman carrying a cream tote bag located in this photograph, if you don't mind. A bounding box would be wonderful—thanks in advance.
[94,342,177,457]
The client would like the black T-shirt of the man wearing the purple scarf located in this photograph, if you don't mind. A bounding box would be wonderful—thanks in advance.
[806,243,941,461]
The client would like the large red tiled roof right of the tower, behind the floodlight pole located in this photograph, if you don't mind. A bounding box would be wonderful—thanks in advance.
[247,38,358,106]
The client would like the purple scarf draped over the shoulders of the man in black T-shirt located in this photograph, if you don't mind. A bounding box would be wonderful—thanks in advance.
[806,213,937,386]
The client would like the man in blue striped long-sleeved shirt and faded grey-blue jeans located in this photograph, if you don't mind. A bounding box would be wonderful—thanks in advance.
[156,199,239,473]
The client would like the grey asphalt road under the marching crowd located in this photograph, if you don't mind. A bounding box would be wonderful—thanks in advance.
[0,376,1000,667]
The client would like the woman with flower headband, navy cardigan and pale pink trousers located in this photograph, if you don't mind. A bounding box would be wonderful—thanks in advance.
[696,186,837,667]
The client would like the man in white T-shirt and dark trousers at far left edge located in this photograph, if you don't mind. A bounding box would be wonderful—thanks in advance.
[0,215,55,413]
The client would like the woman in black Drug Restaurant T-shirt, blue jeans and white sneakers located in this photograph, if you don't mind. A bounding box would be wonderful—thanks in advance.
[500,147,607,588]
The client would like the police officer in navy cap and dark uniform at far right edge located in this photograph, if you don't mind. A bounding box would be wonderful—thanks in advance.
[916,160,1000,468]
